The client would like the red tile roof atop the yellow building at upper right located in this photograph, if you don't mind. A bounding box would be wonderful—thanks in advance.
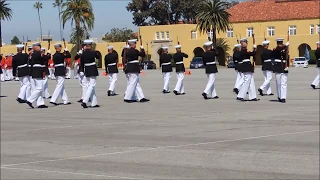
[228,0,320,23]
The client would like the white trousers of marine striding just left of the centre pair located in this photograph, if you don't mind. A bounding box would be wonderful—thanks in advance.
[124,73,144,100]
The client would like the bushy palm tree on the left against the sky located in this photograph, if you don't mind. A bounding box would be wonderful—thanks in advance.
[61,0,94,50]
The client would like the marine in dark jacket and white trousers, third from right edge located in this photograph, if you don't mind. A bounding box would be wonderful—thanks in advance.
[258,40,273,96]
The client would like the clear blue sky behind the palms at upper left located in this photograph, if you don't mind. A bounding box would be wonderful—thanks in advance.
[2,0,138,44]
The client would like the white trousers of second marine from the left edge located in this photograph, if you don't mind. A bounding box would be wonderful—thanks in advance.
[27,78,44,106]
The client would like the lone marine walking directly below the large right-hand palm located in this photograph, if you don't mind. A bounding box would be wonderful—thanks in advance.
[202,42,219,99]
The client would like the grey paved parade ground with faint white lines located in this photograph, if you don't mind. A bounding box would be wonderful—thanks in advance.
[1,67,320,179]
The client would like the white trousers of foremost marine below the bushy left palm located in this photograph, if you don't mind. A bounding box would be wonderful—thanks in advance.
[82,76,98,107]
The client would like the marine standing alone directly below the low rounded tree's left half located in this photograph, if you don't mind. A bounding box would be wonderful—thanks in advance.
[104,46,119,96]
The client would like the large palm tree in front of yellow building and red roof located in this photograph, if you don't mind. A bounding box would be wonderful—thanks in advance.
[196,0,231,47]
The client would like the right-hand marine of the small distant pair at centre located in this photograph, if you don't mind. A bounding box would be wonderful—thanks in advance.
[173,45,189,95]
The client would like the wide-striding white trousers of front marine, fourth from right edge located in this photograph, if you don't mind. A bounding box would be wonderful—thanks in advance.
[237,72,257,100]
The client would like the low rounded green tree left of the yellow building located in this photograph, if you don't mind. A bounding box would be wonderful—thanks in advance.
[102,28,135,42]
